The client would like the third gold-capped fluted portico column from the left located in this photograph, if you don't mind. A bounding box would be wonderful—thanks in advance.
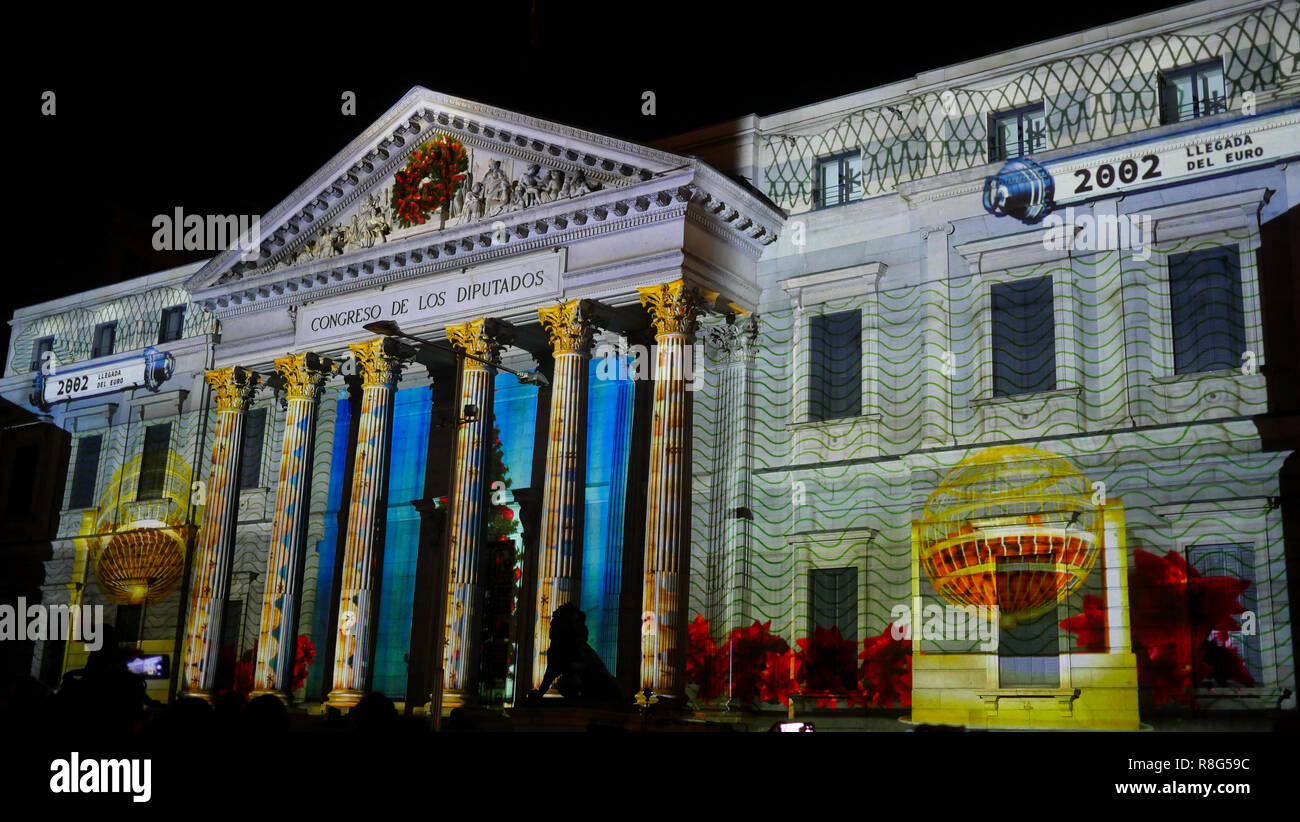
[328,337,410,708]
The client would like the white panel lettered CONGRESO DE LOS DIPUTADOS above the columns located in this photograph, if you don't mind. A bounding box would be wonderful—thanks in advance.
[296,252,563,349]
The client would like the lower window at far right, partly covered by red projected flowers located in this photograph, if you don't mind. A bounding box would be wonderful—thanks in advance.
[1187,544,1262,688]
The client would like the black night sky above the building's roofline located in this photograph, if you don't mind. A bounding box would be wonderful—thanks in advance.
[10,0,1177,358]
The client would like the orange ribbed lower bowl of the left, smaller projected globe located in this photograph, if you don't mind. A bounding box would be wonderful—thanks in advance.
[95,520,185,606]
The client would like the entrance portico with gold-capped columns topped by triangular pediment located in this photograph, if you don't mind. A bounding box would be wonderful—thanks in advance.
[172,88,783,706]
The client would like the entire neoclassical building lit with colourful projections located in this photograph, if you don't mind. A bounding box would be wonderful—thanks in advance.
[0,0,1300,730]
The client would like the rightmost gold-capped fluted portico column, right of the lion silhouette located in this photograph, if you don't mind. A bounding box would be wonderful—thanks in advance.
[637,280,718,696]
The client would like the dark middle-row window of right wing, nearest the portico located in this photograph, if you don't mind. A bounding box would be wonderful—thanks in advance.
[809,310,862,421]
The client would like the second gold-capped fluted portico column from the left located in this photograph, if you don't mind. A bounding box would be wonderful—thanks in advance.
[252,352,334,701]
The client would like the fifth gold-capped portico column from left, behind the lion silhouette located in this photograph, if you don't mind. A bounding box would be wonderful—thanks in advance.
[533,299,601,688]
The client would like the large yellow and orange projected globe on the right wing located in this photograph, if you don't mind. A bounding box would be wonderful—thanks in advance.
[918,446,1101,628]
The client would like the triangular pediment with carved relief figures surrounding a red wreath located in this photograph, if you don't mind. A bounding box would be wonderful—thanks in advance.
[187,87,692,291]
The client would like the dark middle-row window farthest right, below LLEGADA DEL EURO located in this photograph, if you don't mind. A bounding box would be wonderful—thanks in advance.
[1169,246,1245,373]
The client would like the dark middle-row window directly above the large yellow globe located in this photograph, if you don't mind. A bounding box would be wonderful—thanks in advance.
[992,277,1056,397]
